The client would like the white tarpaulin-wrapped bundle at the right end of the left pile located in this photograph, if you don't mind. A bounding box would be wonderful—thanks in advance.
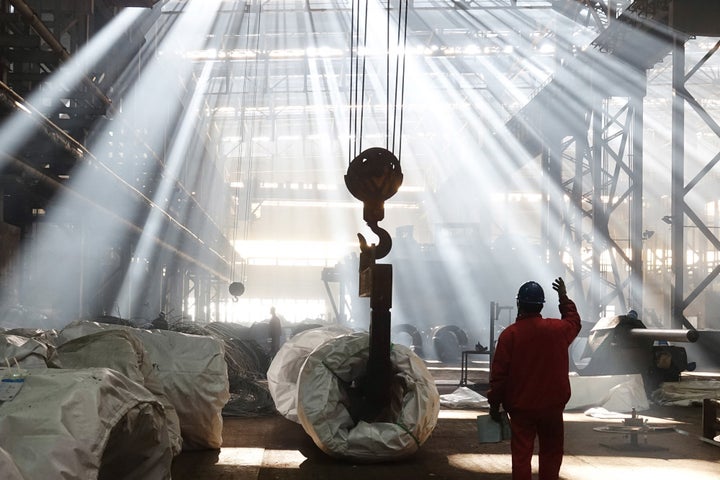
[57,322,230,450]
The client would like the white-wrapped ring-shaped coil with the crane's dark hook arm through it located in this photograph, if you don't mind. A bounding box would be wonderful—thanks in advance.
[297,333,440,462]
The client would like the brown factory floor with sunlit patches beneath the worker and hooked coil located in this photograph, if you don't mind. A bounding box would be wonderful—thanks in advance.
[172,367,720,480]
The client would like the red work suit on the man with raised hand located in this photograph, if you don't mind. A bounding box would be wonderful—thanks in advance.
[487,296,581,480]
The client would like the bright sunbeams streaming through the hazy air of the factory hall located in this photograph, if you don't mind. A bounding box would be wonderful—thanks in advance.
[0,0,718,364]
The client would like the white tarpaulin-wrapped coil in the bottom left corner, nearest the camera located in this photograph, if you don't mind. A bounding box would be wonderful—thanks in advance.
[0,369,173,480]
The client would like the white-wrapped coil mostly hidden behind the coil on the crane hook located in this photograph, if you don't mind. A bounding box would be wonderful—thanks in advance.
[267,325,352,423]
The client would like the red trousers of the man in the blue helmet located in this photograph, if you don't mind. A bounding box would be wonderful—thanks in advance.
[510,408,565,480]
